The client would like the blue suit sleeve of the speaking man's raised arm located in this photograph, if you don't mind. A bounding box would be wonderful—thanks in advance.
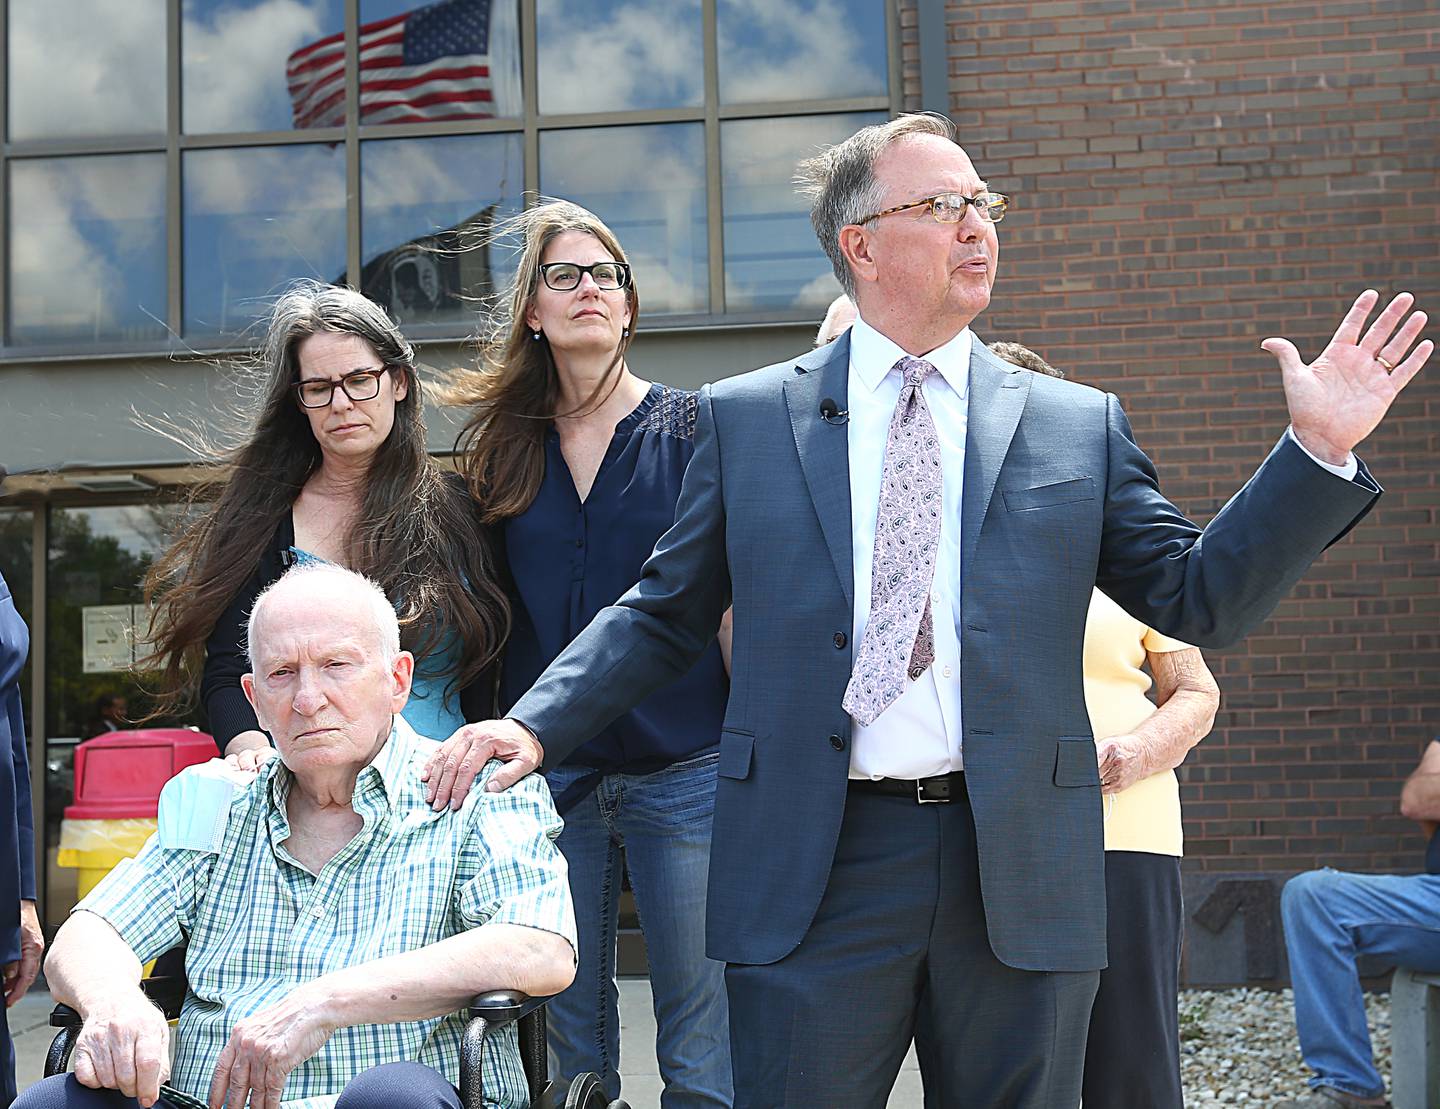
[1097,396,1381,648]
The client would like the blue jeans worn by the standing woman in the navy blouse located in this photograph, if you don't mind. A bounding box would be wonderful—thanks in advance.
[546,752,734,1109]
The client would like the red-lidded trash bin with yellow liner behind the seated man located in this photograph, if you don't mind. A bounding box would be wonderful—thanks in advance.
[55,727,216,897]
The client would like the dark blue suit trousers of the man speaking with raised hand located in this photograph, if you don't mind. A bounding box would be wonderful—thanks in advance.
[726,789,1097,1109]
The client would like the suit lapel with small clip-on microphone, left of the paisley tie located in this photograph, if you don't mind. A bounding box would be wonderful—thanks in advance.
[785,331,855,605]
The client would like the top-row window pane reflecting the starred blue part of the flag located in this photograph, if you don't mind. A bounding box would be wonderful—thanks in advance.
[360,0,523,124]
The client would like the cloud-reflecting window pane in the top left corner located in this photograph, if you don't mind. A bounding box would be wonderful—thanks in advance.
[7,0,166,143]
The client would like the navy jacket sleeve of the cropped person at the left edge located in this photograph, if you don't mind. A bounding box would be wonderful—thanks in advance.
[0,575,35,962]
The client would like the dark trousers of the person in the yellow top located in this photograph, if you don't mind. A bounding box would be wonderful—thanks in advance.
[1084,851,1184,1109]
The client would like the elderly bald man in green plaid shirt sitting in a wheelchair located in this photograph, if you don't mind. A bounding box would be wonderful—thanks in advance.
[16,566,584,1109]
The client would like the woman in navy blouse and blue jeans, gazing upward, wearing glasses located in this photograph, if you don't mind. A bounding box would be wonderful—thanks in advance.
[429,202,733,1109]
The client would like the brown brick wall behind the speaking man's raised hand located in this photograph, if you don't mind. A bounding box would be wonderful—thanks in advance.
[900,0,1440,877]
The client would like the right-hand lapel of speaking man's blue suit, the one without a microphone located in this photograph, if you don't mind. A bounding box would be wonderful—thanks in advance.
[960,337,1032,592]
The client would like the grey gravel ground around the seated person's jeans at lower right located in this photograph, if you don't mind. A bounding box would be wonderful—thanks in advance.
[1179,989,1390,1109]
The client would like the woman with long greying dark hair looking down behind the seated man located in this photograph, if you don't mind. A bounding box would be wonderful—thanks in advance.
[147,282,508,769]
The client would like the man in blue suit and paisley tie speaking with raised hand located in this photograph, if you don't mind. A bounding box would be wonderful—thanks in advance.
[431,115,1433,1109]
